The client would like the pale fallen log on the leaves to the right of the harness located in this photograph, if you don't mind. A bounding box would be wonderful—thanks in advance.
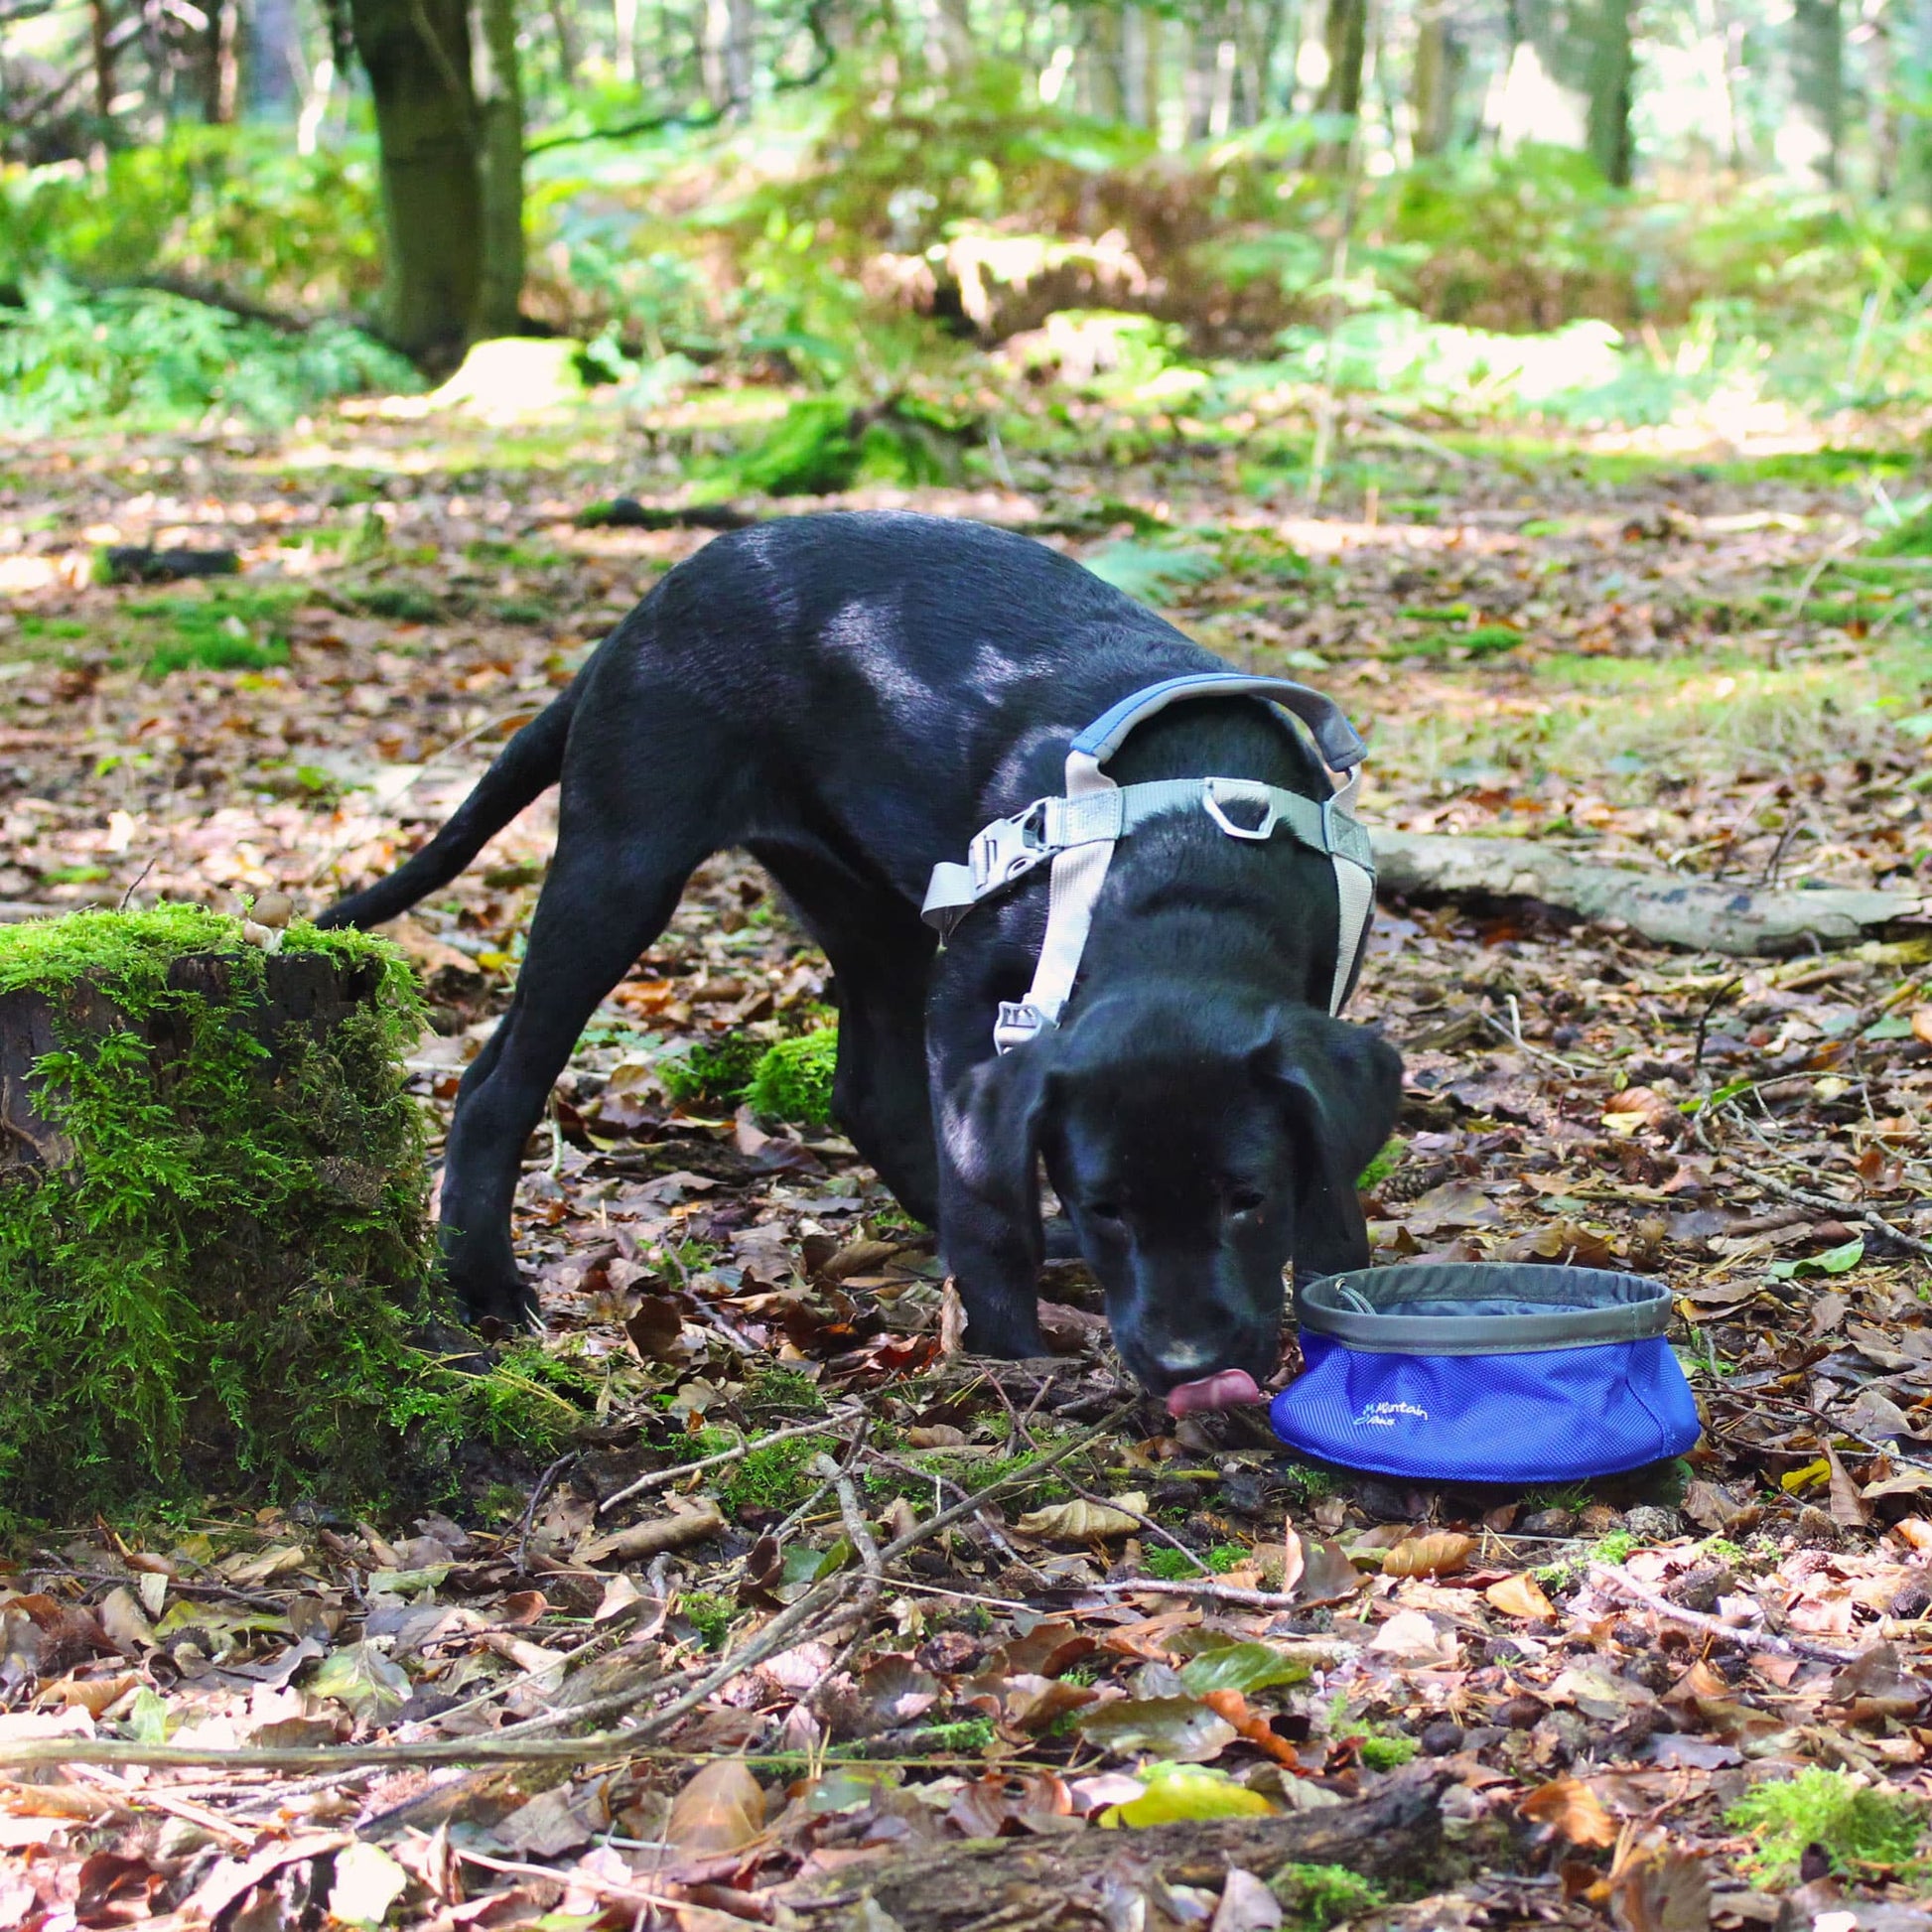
[1376,829,1932,956]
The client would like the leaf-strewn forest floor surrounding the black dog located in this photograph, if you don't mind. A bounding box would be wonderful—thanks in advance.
[0,407,1932,1932]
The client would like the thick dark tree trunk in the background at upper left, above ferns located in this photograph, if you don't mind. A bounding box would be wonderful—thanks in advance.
[349,0,483,375]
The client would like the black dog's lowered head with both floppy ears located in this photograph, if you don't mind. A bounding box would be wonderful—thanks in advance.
[954,987,1403,1395]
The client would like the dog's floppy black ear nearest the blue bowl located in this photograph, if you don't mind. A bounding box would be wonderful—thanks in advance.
[1256,1007,1403,1281]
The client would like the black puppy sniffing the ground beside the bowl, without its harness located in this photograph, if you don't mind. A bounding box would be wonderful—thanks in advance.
[321,514,1401,1393]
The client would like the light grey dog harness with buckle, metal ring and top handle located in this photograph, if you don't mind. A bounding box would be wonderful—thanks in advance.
[919,670,1376,1053]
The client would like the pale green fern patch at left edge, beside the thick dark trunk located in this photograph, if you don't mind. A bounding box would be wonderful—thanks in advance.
[0,274,417,431]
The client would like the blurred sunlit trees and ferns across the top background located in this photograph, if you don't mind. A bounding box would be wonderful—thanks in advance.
[0,0,1932,429]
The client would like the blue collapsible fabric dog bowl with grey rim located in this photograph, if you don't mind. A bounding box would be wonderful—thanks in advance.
[1270,1262,1700,1484]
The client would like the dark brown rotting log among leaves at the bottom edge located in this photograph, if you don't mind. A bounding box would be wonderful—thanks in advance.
[813,1768,1449,1932]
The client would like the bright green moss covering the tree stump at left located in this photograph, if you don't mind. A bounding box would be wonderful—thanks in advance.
[0,906,576,1519]
